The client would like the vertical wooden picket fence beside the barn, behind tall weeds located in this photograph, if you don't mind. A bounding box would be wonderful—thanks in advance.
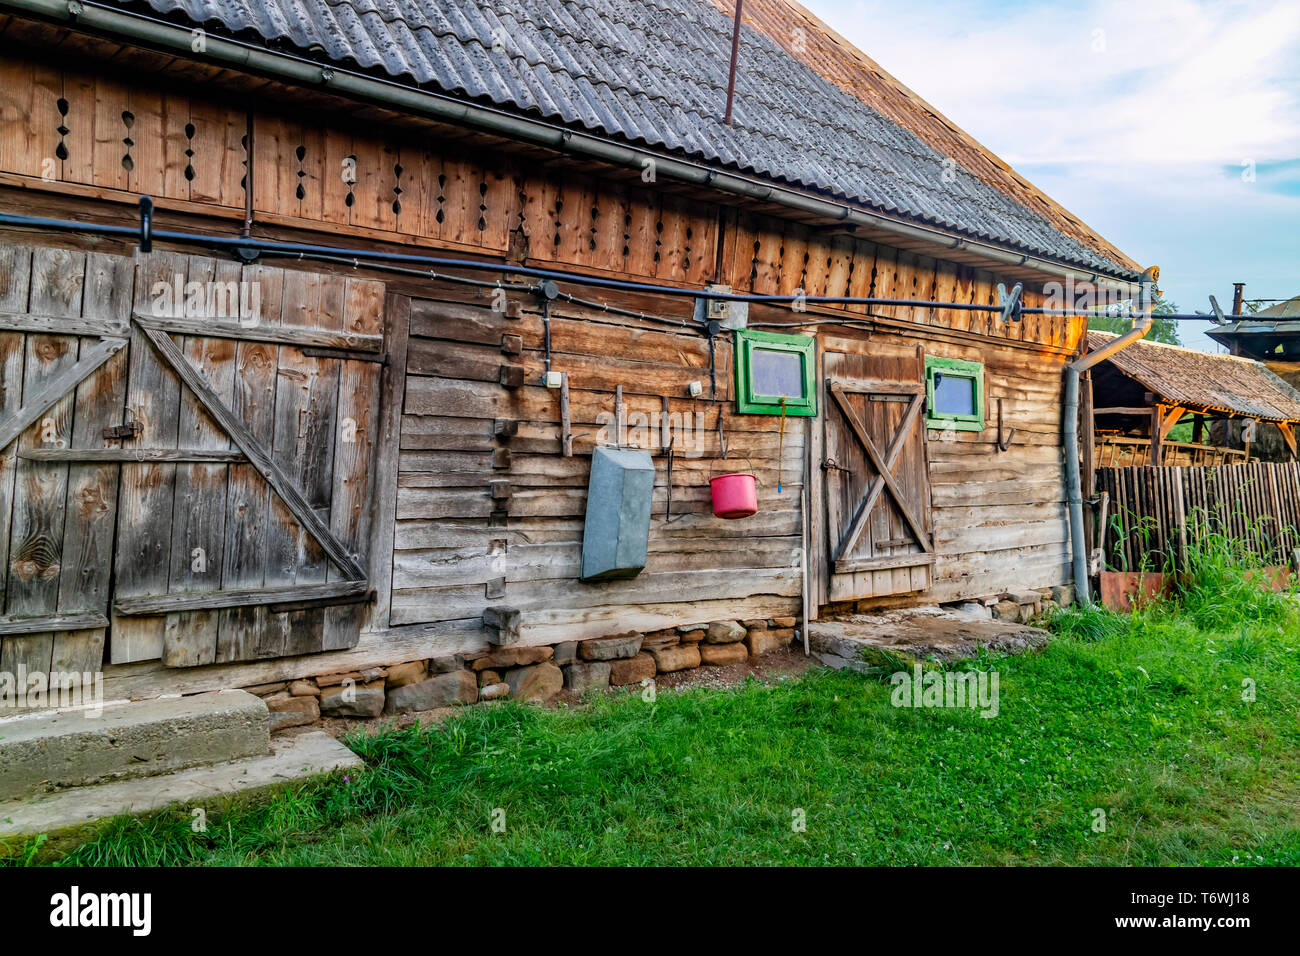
[1096,462,1300,571]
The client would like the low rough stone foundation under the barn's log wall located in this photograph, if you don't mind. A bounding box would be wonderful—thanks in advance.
[243,618,797,734]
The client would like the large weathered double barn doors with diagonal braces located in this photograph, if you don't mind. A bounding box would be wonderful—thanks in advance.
[0,246,384,671]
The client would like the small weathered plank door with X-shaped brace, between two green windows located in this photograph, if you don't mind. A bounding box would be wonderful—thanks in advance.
[820,349,935,601]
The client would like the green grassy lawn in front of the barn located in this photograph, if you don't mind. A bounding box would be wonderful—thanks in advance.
[17,561,1300,865]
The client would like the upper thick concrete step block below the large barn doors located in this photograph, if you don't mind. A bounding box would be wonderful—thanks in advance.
[0,691,270,801]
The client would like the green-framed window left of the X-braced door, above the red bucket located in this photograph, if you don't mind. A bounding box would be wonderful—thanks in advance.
[736,329,816,416]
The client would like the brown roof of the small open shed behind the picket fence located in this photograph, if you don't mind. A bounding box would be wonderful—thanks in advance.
[1088,332,1300,421]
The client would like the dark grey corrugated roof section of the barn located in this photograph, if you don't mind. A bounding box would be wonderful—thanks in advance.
[121,0,1130,276]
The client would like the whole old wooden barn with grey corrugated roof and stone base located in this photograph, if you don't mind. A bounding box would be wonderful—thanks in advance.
[0,0,1141,722]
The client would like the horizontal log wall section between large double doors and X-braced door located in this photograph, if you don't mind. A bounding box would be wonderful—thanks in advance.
[391,287,805,644]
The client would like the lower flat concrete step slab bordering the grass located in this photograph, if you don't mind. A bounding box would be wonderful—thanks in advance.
[0,731,361,858]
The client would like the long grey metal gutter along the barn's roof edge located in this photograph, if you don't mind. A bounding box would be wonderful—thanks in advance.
[0,0,1139,293]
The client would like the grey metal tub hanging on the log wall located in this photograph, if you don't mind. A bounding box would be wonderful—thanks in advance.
[582,447,654,581]
